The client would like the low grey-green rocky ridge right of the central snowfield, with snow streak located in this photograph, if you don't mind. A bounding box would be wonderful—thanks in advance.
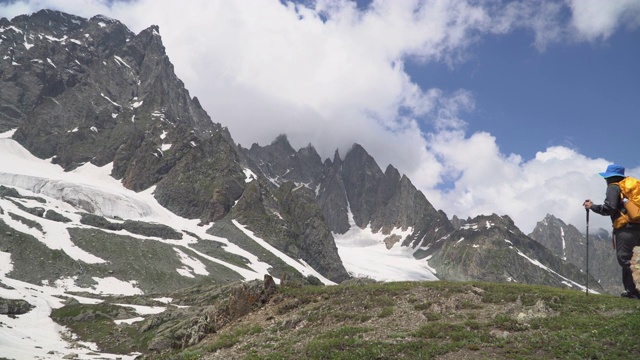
[429,214,604,292]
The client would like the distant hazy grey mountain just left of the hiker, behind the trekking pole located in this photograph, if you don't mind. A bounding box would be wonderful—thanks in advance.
[529,214,622,294]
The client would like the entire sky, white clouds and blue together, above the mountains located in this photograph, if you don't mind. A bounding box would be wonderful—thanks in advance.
[0,0,640,232]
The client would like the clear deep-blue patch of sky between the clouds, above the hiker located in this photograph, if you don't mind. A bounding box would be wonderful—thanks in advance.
[406,23,640,168]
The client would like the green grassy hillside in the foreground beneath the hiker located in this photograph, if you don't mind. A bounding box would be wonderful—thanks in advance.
[131,281,640,359]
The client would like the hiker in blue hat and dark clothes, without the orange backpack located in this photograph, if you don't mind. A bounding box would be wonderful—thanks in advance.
[584,164,640,299]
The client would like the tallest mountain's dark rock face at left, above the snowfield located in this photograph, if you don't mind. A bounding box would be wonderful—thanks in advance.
[0,10,244,222]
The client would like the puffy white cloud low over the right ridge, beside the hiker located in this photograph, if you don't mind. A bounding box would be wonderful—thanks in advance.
[427,131,624,233]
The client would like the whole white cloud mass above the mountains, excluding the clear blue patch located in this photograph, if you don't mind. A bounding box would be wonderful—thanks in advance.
[0,0,638,232]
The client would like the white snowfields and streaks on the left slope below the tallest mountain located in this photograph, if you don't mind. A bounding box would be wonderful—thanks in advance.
[0,131,332,359]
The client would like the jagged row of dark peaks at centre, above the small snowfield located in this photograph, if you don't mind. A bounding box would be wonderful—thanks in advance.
[246,141,453,247]
